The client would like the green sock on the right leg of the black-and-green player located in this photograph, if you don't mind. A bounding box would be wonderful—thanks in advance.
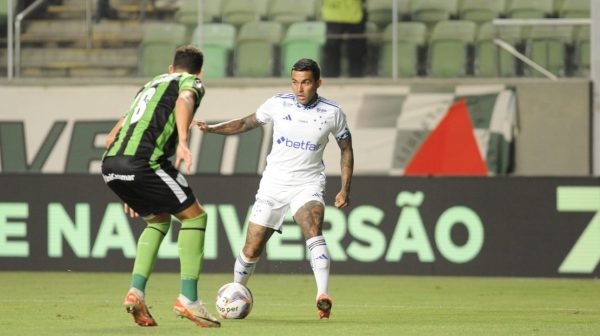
[177,213,206,301]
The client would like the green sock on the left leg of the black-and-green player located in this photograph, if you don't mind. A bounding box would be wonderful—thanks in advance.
[131,222,171,292]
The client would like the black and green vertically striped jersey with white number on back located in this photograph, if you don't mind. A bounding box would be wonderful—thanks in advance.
[104,72,205,168]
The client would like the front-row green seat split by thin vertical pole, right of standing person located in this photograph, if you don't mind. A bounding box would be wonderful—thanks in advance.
[379,22,427,77]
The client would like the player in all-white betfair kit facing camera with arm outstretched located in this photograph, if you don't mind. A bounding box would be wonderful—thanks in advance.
[193,59,354,319]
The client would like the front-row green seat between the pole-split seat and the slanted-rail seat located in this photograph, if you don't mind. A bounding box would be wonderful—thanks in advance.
[428,20,477,77]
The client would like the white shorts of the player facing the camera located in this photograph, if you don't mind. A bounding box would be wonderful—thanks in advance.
[250,180,325,232]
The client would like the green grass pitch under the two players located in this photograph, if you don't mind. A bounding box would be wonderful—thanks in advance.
[0,272,600,336]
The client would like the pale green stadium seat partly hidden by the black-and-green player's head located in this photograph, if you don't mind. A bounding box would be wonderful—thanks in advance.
[140,23,186,76]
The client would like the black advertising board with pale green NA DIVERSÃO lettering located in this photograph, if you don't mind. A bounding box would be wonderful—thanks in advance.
[0,174,600,277]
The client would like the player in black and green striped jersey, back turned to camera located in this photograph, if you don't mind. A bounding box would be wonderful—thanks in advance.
[102,46,220,327]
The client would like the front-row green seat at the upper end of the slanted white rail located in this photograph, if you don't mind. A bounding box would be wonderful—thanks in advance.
[475,22,522,77]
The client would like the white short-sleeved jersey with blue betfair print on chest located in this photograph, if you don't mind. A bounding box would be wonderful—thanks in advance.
[256,93,350,185]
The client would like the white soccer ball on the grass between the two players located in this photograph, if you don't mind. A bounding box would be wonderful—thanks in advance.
[216,282,253,319]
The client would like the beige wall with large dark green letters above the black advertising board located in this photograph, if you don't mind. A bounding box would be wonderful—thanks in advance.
[0,79,591,176]
